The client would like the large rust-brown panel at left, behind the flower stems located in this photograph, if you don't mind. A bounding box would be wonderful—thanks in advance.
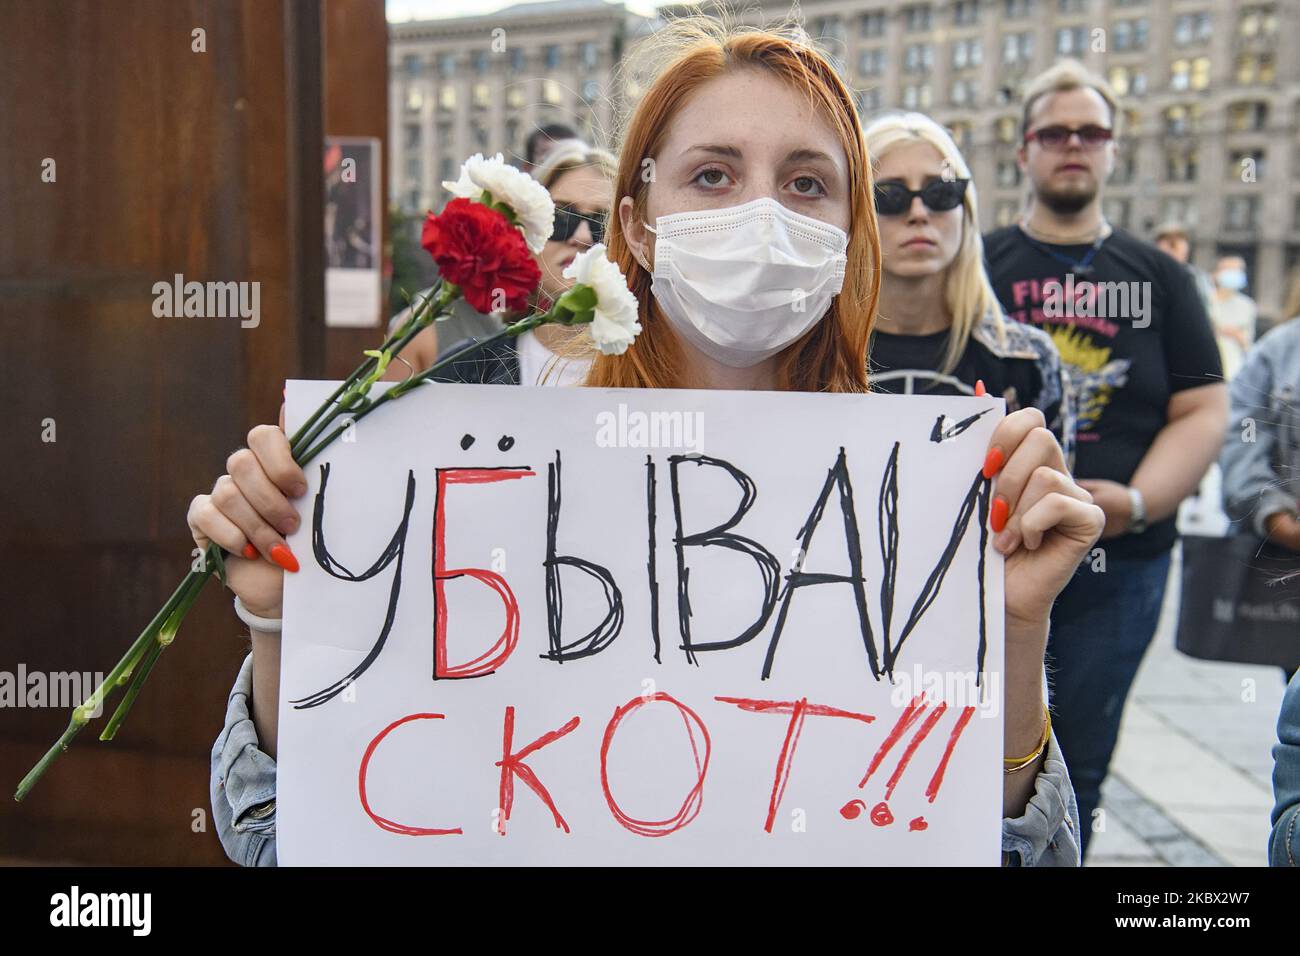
[0,0,343,864]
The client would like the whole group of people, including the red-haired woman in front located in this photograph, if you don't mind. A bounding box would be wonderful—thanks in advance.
[190,18,1300,865]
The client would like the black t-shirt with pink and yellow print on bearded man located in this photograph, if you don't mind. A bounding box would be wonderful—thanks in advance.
[984,225,1223,557]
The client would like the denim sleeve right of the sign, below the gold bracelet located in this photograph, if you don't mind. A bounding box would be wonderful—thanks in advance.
[1002,734,1079,866]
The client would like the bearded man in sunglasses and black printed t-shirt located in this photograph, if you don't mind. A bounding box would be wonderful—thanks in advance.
[984,60,1227,849]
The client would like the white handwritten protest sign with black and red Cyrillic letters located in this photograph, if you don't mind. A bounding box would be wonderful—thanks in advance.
[277,381,1005,865]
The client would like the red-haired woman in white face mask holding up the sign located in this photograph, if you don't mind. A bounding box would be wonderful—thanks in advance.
[197,18,1104,866]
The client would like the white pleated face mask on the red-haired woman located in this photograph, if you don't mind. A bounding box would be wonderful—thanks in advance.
[646,198,849,368]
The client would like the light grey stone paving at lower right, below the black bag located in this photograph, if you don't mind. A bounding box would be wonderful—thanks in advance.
[1087,554,1283,866]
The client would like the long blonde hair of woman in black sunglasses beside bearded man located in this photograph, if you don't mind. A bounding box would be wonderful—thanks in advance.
[863,113,1006,373]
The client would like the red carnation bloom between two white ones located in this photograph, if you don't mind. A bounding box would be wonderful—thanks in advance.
[420,198,542,315]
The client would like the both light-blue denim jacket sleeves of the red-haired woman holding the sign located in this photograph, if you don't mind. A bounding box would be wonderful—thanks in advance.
[209,654,1081,866]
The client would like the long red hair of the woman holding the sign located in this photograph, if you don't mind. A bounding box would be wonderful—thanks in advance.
[586,17,880,392]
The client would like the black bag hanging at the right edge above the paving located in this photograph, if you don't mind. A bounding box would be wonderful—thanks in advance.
[1175,535,1300,671]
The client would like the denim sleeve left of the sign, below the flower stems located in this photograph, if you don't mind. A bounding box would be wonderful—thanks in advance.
[209,654,276,866]
